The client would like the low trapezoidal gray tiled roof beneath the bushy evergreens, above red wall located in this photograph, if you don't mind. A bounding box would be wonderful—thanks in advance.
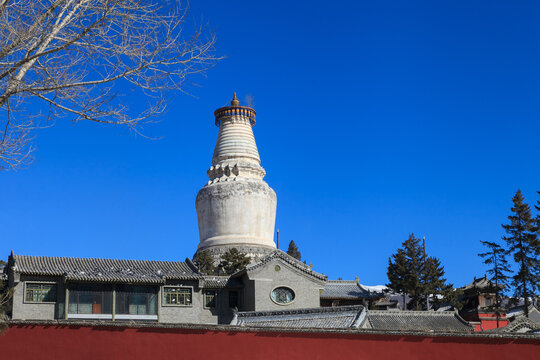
[362,310,473,332]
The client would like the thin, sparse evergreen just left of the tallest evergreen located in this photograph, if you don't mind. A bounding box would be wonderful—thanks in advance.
[478,241,510,328]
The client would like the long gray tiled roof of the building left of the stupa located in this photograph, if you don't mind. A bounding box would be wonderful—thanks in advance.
[12,255,202,284]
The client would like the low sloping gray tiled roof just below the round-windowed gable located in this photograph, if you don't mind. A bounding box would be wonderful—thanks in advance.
[231,305,365,329]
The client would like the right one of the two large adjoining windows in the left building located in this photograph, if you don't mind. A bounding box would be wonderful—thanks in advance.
[116,285,157,315]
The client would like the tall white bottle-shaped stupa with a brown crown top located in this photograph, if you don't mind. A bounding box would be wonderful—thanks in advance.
[195,93,277,260]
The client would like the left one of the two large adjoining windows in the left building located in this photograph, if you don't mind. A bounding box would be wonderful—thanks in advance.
[68,284,112,314]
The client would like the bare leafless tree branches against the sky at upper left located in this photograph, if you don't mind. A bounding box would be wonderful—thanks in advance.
[0,0,219,170]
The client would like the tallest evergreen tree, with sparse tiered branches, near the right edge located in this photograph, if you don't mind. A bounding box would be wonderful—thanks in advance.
[502,189,540,317]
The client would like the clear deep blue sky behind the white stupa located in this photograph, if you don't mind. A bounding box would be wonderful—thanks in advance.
[0,0,540,285]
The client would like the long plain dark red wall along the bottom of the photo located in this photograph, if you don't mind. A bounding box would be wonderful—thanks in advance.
[0,324,540,360]
